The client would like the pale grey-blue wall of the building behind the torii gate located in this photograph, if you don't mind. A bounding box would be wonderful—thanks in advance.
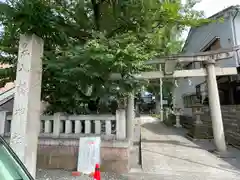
[174,12,240,116]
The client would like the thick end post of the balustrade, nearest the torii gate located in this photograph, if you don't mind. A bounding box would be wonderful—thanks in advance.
[116,109,126,140]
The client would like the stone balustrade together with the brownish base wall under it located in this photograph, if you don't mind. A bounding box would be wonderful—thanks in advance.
[0,109,130,173]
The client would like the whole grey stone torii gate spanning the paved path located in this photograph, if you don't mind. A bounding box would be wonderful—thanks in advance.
[111,46,240,153]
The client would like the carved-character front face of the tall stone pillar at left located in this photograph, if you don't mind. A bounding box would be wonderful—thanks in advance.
[10,37,30,162]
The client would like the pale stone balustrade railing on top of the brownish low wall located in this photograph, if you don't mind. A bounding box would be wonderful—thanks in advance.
[0,110,126,140]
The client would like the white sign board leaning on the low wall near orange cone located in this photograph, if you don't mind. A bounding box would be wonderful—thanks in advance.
[77,137,101,174]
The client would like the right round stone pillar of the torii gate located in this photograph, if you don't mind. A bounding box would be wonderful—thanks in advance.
[205,60,227,152]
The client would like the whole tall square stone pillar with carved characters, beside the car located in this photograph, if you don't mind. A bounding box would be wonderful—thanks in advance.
[10,35,43,178]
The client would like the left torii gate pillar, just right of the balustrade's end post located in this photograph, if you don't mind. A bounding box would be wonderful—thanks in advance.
[127,93,135,140]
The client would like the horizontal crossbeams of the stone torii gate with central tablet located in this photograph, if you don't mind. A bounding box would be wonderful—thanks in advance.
[110,46,240,80]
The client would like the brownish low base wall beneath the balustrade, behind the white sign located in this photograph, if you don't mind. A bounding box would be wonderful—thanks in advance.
[37,139,130,174]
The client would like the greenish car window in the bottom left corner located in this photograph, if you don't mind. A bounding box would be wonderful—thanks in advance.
[0,136,33,180]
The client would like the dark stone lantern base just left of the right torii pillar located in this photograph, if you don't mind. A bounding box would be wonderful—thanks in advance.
[187,123,213,139]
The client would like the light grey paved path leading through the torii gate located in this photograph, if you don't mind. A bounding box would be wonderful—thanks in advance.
[141,119,240,180]
